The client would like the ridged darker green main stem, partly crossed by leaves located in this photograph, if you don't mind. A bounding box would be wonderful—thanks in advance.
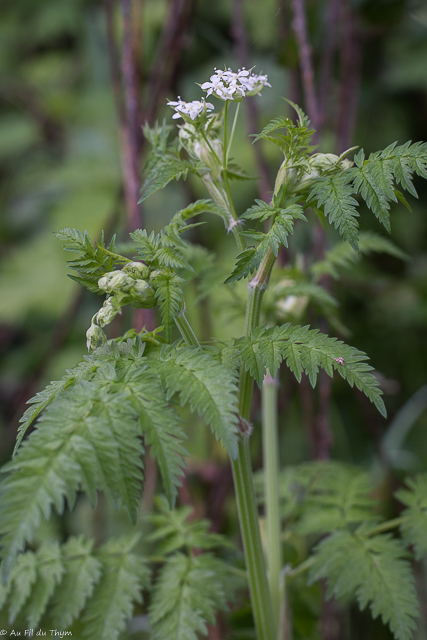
[232,245,277,640]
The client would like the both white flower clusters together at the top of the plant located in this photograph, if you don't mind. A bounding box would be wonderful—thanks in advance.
[168,68,271,124]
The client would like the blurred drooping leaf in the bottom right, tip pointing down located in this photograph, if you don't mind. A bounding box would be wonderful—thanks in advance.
[310,525,418,640]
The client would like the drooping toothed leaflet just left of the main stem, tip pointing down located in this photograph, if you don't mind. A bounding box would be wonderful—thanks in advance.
[156,347,238,457]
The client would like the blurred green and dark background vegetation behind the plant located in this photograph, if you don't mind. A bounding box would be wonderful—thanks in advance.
[0,0,427,639]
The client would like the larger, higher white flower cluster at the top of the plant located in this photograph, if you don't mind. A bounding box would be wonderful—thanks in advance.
[201,68,271,100]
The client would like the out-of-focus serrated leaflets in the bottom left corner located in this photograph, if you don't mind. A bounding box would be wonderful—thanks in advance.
[3,536,150,640]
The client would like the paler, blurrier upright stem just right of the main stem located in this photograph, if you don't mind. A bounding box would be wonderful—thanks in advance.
[262,371,284,626]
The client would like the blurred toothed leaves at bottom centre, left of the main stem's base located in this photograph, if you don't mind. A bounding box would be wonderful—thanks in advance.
[149,497,236,640]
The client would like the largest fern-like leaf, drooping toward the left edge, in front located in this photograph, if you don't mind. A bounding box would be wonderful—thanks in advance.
[0,367,143,576]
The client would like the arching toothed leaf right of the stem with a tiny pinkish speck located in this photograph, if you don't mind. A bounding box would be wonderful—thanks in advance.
[229,324,385,415]
